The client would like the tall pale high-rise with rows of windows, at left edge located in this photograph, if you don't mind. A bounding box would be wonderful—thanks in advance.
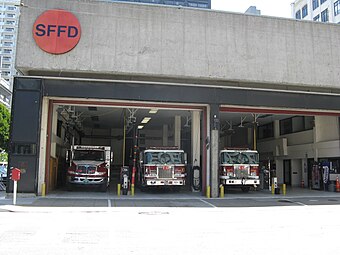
[0,0,20,91]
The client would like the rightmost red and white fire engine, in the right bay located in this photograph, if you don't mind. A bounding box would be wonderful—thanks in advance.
[219,149,260,192]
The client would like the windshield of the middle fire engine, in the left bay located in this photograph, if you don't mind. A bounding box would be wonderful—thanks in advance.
[145,151,184,164]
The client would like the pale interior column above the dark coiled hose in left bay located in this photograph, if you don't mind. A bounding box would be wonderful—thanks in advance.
[191,111,201,166]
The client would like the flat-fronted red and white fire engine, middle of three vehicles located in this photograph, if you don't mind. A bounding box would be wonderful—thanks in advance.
[138,147,187,190]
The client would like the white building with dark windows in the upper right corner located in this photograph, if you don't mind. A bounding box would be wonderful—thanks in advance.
[292,0,340,23]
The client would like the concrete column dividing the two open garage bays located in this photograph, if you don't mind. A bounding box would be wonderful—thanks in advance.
[210,102,220,198]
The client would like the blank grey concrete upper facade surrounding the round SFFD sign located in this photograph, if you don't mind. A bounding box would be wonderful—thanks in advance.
[17,0,340,91]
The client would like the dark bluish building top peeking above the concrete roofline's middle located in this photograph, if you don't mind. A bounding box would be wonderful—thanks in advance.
[108,0,211,9]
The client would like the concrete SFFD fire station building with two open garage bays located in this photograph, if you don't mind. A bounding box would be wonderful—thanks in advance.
[9,0,340,197]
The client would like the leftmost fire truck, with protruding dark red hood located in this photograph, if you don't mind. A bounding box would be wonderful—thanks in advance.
[66,145,112,192]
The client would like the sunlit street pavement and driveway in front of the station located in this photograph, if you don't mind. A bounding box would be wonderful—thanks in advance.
[0,188,340,255]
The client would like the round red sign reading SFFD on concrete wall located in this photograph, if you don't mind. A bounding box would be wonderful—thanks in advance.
[33,10,81,54]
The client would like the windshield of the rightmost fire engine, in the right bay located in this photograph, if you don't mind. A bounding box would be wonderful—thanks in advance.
[221,151,259,164]
